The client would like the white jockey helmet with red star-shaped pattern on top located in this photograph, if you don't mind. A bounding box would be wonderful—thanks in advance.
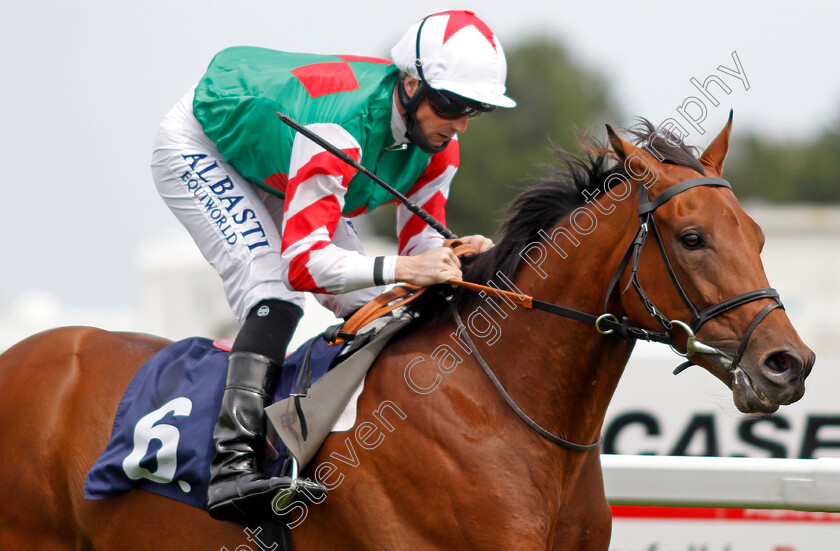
[391,10,516,110]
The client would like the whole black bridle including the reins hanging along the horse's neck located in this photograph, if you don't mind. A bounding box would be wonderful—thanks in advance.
[449,177,784,451]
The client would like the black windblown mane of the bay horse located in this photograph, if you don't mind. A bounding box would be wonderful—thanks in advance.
[404,118,705,319]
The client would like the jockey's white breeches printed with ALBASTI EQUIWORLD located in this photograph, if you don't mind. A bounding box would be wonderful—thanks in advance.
[152,92,383,322]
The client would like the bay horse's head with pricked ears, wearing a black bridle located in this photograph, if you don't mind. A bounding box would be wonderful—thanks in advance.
[609,116,815,413]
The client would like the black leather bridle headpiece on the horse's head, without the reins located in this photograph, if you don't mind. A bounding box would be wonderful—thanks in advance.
[608,177,784,374]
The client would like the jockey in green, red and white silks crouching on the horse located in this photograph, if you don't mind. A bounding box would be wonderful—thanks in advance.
[152,11,516,520]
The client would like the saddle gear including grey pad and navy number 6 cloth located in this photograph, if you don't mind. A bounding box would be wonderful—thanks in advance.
[85,242,488,508]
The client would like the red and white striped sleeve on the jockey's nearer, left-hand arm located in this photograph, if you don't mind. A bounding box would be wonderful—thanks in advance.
[281,124,395,294]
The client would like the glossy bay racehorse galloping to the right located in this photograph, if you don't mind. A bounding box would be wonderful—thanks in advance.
[0,116,814,551]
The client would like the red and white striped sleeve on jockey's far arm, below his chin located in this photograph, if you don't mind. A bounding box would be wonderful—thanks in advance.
[397,136,459,256]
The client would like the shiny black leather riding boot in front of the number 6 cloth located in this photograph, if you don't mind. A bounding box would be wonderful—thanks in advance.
[207,352,291,521]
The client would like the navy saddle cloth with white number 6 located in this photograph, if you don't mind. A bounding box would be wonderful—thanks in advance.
[84,337,346,509]
